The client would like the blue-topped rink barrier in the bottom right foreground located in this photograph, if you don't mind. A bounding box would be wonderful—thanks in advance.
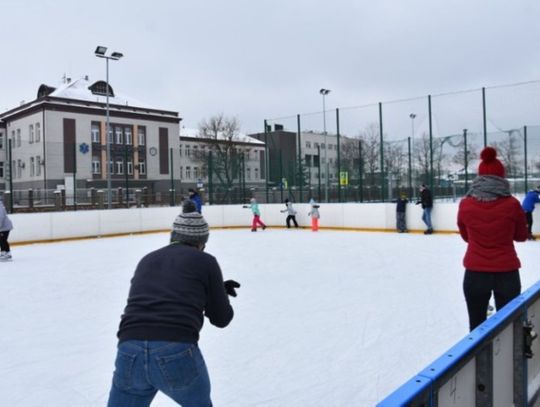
[377,281,540,407]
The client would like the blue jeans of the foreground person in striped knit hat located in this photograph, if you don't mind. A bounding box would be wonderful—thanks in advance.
[107,340,212,407]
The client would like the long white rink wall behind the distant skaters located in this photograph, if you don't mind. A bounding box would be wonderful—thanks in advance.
[9,202,540,243]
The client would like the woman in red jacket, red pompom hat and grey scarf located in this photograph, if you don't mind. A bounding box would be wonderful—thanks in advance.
[458,147,527,331]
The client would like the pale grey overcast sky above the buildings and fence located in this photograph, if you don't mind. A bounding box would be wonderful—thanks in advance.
[0,0,540,137]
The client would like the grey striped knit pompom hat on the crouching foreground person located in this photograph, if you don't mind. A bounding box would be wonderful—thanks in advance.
[171,200,209,246]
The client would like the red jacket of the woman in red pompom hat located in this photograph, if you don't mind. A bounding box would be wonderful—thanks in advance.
[458,196,528,271]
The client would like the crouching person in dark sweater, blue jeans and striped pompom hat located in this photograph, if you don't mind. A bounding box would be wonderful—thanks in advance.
[108,201,240,407]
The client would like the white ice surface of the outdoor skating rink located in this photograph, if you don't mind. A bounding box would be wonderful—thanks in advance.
[0,229,538,407]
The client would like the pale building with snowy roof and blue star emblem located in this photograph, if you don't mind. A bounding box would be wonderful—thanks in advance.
[0,77,181,204]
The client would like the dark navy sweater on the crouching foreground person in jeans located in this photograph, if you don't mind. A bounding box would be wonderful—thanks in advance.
[118,244,233,343]
